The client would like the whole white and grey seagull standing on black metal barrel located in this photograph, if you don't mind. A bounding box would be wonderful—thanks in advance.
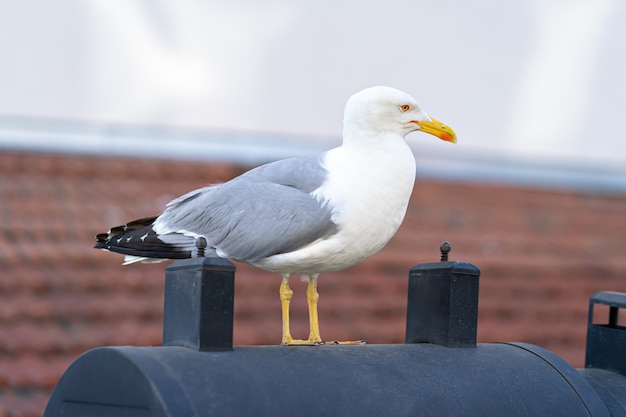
[95,86,456,345]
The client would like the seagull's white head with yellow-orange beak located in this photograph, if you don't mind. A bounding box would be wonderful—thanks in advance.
[344,87,456,143]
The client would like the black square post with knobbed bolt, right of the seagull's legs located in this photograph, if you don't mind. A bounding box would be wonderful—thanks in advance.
[405,242,480,347]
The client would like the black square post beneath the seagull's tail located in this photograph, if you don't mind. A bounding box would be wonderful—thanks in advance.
[163,257,235,351]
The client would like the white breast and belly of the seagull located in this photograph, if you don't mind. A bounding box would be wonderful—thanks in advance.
[254,135,415,274]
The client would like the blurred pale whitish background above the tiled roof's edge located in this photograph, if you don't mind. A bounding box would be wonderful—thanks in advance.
[0,0,626,169]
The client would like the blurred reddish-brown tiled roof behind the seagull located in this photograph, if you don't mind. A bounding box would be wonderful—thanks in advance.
[0,152,626,417]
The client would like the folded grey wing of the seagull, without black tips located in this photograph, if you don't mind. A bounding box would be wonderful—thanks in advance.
[155,156,337,262]
